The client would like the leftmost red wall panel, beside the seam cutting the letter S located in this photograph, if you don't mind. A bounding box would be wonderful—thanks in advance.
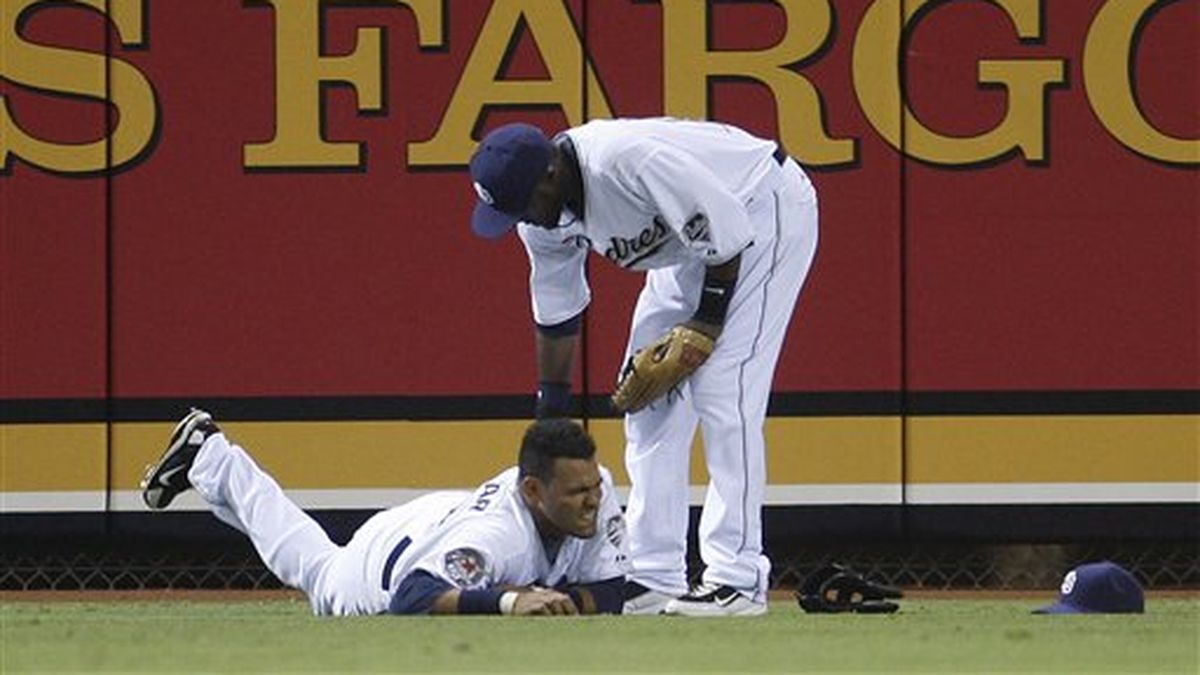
[0,4,108,399]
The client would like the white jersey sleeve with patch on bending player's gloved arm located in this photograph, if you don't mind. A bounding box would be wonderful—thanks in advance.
[632,147,754,265]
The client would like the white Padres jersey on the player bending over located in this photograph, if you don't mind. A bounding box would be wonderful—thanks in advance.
[517,118,811,325]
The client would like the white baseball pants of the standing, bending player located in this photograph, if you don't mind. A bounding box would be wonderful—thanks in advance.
[625,160,817,602]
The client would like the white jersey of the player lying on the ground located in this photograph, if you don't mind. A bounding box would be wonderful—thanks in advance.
[376,467,626,590]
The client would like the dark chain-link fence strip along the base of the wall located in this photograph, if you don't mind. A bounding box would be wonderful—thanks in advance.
[0,540,1200,591]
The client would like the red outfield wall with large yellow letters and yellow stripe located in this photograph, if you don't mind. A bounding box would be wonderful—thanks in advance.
[0,0,1200,537]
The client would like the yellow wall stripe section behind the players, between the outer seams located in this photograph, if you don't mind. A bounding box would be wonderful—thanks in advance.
[113,418,900,490]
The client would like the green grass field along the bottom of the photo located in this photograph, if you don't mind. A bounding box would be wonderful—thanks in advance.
[0,599,1200,673]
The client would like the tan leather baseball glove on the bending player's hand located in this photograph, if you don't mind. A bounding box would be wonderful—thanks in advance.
[612,324,716,412]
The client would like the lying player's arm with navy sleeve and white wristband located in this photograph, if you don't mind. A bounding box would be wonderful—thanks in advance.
[388,569,578,616]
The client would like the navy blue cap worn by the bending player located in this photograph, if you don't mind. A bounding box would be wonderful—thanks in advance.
[470,123,553,239]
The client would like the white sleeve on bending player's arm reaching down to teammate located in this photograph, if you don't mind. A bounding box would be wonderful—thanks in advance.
[517,223,592,325]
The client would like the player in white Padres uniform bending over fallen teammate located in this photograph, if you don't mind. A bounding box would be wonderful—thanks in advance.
[470,118,817,616]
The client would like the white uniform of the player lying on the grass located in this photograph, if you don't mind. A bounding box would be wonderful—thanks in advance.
[187,434,626,615]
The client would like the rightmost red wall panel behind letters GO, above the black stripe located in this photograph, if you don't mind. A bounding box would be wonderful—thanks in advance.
[905,2,1200,390]
